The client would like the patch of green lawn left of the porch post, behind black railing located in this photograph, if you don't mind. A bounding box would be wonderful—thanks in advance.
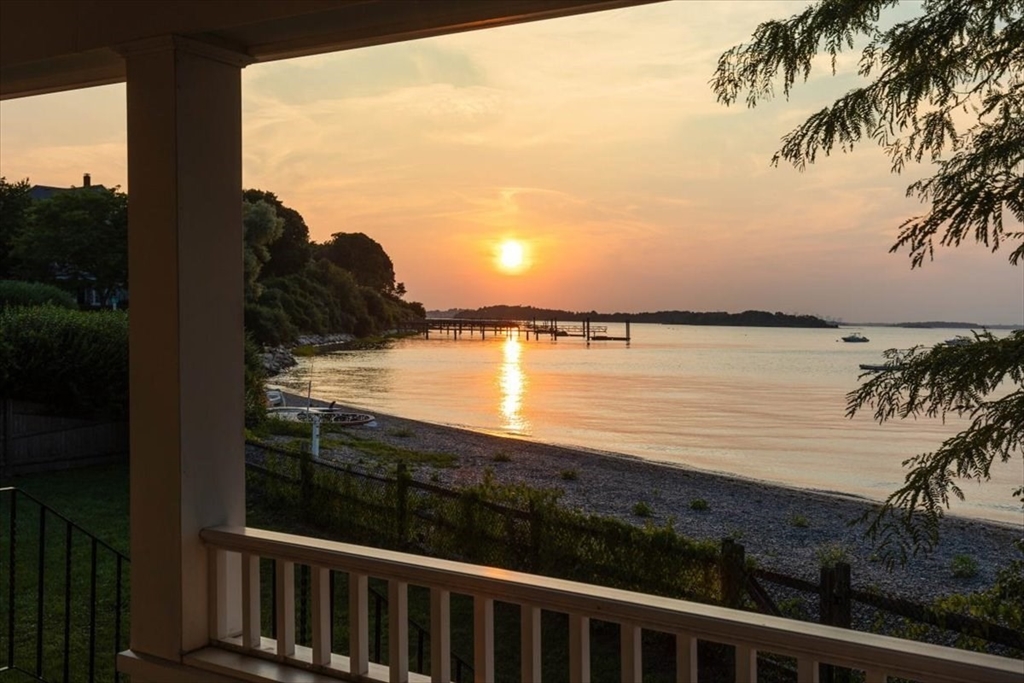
[0,465,130,681]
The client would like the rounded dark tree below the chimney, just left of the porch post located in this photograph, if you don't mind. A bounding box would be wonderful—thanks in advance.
[11,187,128,301]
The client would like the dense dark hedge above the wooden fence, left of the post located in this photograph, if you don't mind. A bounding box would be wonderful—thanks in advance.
[0,305,128,418]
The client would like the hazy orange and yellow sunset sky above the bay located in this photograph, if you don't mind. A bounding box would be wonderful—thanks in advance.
[0,0,1024,325]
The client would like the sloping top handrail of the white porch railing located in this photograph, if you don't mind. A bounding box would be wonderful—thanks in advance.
[201,526,1024,683]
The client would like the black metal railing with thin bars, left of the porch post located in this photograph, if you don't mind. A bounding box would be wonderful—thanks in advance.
[0,487,129,683]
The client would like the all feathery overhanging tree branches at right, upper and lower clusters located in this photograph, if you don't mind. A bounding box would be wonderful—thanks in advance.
[712,0,1024,563]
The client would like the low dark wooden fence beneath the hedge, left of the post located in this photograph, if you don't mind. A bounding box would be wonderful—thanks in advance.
[0,398,128,477]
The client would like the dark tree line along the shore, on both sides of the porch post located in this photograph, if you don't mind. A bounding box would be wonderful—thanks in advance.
[0,177,425,344]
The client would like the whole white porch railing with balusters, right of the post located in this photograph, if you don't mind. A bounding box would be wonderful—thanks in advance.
[194,527,1024,683]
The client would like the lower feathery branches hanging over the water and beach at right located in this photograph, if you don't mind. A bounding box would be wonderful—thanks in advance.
[847,330,1024,565]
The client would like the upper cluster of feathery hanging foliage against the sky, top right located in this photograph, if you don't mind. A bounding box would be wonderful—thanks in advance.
[711,0,1024,267]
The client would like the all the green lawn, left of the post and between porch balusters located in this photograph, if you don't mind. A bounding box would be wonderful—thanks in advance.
[0,465,737,681]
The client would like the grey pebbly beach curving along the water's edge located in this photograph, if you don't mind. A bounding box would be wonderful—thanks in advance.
[276,389,1022,600]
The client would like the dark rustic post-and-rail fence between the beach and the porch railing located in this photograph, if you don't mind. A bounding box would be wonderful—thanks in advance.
[247,442,1024,659]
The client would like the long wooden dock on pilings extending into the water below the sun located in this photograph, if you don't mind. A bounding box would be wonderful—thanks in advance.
[395,317,631,346]
